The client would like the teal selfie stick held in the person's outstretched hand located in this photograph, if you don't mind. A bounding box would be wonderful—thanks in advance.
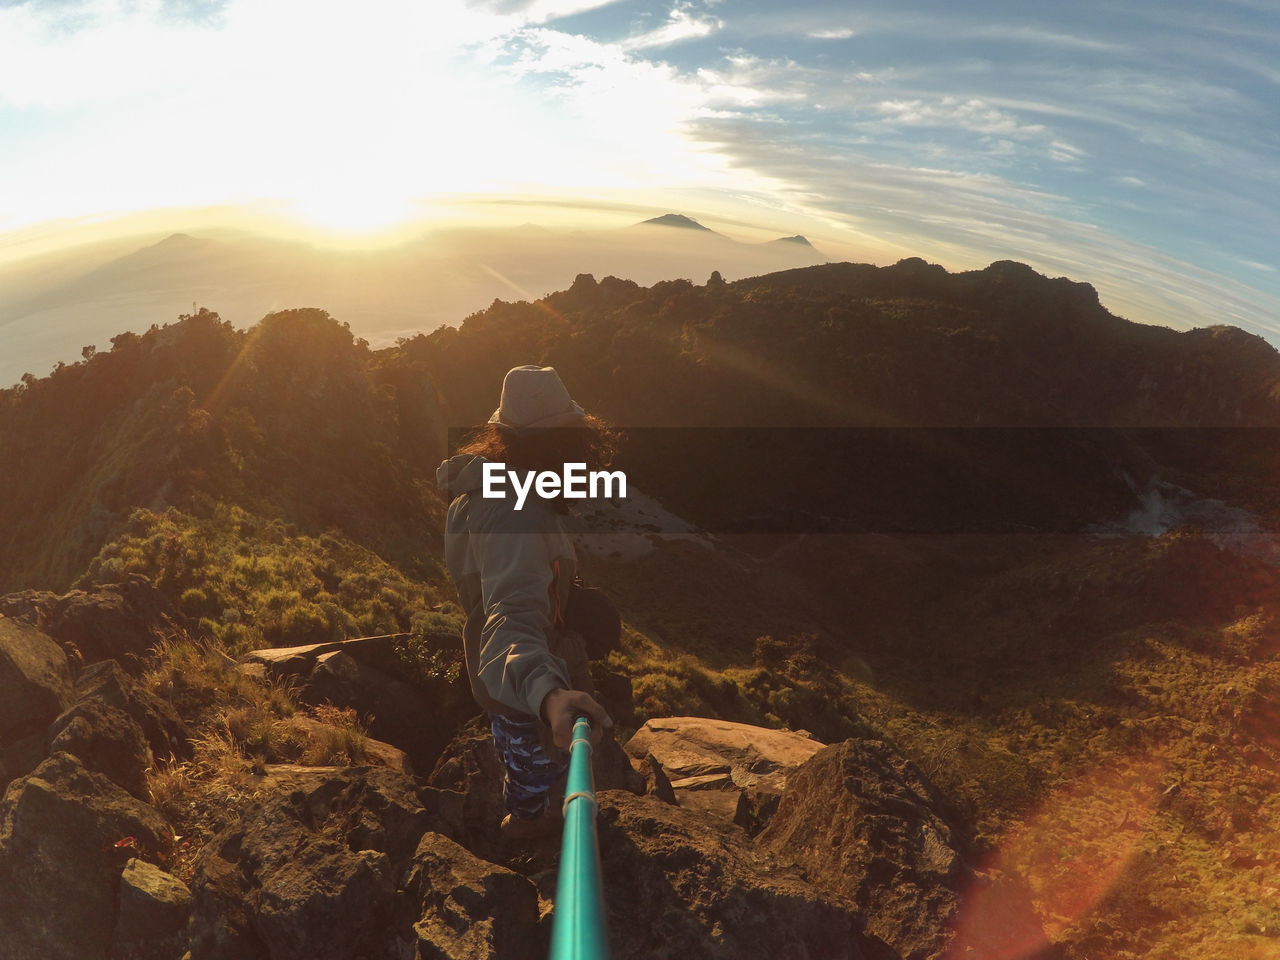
[552,717,609,960]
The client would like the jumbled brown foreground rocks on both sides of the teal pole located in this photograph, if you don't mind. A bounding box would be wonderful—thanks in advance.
[0,601,1043,960]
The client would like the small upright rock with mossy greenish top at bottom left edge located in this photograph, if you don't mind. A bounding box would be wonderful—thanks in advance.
[111,860,191,960]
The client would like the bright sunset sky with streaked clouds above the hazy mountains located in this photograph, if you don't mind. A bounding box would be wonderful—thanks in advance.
[0,0,1280,344]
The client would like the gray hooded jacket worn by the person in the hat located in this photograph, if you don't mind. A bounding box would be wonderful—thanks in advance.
[435,454,576,717]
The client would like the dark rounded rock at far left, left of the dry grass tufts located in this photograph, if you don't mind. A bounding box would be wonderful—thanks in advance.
[49,698,152,801]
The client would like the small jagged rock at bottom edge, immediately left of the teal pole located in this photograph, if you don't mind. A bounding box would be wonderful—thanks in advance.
[406,833,547,960]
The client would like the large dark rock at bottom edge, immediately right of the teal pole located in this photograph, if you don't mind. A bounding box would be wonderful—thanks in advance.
[598,791,892,960]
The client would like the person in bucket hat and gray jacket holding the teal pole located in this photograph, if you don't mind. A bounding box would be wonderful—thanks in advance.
[436,365,618,840]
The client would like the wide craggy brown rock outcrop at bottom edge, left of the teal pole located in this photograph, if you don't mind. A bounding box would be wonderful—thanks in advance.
[189,767,544,960]
